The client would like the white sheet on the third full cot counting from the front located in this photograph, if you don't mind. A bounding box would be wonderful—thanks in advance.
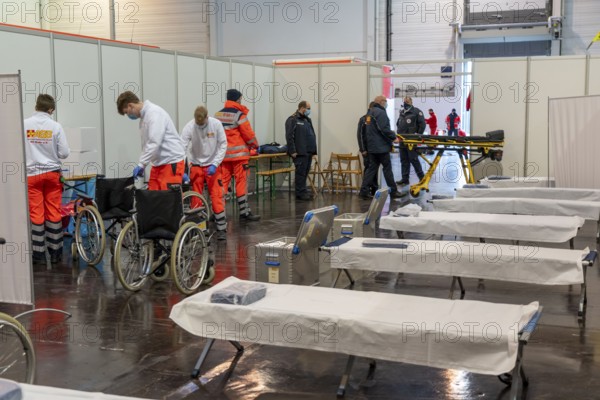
[379,211,585,243]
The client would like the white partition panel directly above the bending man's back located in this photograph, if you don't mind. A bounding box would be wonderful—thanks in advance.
[142,50,178,126]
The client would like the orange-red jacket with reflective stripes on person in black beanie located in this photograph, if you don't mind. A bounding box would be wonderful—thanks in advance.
[215,100,258,162]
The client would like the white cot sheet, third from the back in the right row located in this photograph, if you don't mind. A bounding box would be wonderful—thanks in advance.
[432,197,600,221]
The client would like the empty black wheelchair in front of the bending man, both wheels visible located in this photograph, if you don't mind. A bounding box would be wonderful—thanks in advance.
[114,185,214,295]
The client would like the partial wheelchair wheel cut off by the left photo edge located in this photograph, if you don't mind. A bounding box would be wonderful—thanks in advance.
[0,313,35,383]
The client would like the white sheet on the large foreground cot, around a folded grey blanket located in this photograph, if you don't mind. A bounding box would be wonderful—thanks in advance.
[170,277,538,375]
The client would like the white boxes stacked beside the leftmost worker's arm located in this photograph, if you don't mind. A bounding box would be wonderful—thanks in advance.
[63,127,102,177]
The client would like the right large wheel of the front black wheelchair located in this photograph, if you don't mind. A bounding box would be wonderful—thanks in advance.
[171,222,208,295]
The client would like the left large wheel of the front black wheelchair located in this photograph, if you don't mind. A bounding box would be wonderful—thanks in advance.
[114,221,154,292]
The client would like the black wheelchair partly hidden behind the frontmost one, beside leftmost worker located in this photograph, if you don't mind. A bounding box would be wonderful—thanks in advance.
[71,175,133,265]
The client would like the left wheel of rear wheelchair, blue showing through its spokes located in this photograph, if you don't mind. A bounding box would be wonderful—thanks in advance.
[75,205,106,265]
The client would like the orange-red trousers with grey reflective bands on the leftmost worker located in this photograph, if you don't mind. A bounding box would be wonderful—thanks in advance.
[27,171,63,257]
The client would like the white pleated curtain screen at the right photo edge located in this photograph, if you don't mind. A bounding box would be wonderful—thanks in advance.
[548,96,600,189]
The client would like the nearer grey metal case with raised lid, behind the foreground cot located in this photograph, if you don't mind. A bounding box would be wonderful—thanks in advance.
[255,206,338,285]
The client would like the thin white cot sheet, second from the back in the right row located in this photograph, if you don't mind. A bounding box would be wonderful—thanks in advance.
[456,187,600,201]
